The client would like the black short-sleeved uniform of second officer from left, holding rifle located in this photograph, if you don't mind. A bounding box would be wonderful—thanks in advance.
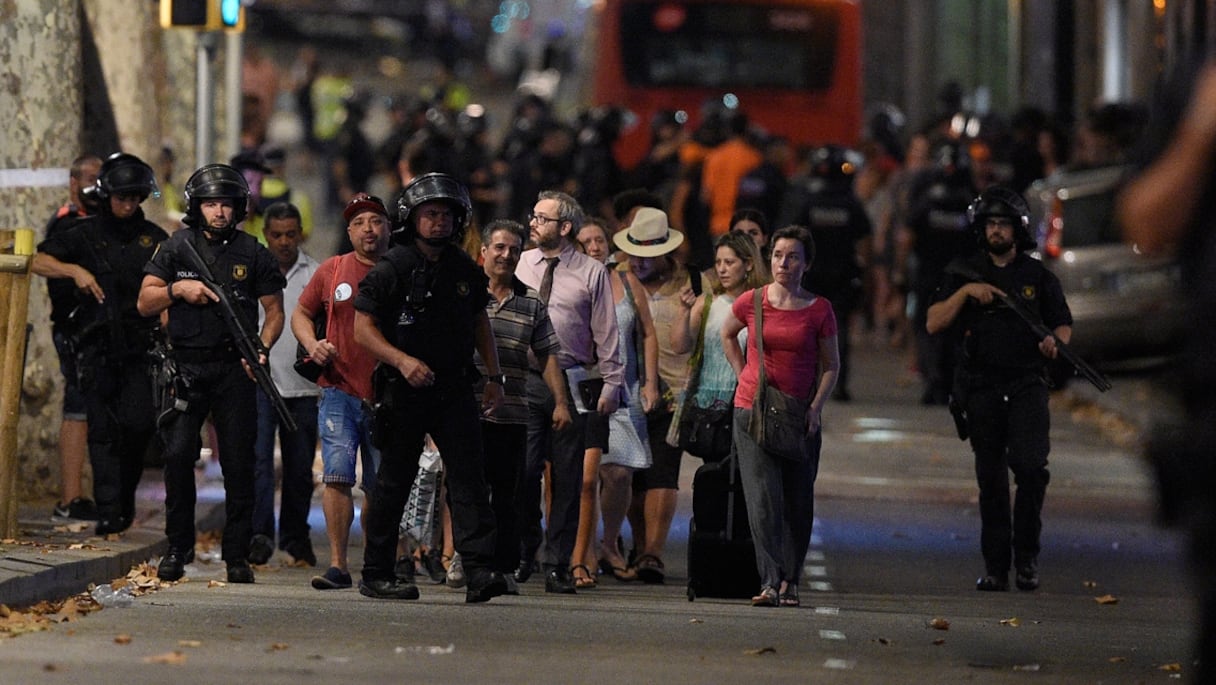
[145,229,286,563]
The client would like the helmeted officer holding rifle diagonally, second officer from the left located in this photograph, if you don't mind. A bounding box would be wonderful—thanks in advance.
[139,164,285,583]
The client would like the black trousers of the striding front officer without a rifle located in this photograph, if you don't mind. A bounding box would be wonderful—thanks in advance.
[364,378,495,580]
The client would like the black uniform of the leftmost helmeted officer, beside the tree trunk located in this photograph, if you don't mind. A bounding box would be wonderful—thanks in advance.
[38,210,169,532]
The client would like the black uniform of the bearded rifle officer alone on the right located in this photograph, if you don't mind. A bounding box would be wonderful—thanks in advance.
[934,253,1073,579]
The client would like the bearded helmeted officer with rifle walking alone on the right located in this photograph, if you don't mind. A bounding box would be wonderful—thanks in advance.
[927,186,1073,591]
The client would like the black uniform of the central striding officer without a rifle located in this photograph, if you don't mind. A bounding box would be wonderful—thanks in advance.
[355,242,495,582]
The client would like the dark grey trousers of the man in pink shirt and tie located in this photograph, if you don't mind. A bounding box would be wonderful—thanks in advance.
[517,374,587,569]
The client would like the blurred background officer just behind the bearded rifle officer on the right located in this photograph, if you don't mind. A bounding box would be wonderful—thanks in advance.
[907,141,976,404]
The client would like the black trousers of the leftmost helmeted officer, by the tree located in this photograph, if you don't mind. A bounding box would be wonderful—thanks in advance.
[85,358,156,521]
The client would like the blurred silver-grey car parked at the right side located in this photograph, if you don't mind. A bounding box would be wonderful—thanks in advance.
[1026,164,1184,364]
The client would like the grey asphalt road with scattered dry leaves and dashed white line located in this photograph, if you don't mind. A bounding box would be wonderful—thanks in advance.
[0,335,1192,684]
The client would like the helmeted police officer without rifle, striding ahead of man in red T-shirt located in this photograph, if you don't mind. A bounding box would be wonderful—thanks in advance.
[355,174,507,602]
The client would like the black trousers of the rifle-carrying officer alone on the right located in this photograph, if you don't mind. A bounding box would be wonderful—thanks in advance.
[967,377,1051,577]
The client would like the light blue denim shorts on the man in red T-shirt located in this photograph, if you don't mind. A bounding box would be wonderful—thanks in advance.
[316,388,379,493]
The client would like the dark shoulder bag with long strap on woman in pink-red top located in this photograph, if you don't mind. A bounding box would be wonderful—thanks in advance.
[748,288,811,461]
